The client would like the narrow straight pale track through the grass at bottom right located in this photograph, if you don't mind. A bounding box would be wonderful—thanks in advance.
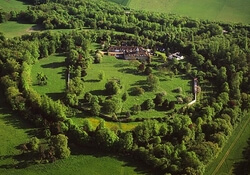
[212,117,250,175]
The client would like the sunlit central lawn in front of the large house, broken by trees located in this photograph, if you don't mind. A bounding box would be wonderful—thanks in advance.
[85,56,192,117]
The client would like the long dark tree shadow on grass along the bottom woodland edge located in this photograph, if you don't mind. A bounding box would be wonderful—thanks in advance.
[70,144,159,175]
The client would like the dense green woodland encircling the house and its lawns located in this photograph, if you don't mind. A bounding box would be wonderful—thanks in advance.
[0,0,250,175]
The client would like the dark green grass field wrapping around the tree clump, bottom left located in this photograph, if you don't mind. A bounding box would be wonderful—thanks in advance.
[0,91,147,175]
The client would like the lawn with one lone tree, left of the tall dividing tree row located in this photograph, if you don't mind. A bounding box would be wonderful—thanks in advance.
[31,55,66,100]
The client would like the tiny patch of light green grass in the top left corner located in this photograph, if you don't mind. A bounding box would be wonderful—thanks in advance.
[0,0,28,11]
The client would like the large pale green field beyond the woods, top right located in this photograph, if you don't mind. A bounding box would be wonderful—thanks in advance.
[110,0,250,23]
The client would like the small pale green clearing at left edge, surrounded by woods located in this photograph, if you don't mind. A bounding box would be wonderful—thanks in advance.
[0,21,34,38]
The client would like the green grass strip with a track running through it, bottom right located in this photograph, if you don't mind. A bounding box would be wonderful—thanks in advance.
[205,113,250,175]
